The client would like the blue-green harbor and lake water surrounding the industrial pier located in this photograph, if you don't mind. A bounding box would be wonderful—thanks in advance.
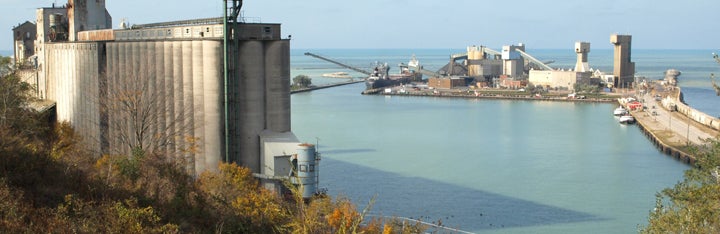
[291,49,720,233]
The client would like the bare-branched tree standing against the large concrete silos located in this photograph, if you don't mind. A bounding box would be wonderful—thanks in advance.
[99,58,198,161]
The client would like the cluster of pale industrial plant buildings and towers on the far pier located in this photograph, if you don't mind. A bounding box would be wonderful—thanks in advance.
[424,38,635,90]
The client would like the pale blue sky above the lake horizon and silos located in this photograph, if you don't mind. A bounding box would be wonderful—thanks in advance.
[0,0,720,50]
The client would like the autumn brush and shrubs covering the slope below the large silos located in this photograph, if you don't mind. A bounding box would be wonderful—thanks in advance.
[0,55,421,233]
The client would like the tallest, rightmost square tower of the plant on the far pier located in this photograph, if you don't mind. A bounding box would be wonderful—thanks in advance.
[610,34,635,87]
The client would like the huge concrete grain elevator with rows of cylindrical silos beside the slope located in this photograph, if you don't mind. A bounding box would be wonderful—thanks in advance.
[14,0,319,197]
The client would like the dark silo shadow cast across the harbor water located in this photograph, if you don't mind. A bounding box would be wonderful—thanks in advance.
[320,158,607,231]
